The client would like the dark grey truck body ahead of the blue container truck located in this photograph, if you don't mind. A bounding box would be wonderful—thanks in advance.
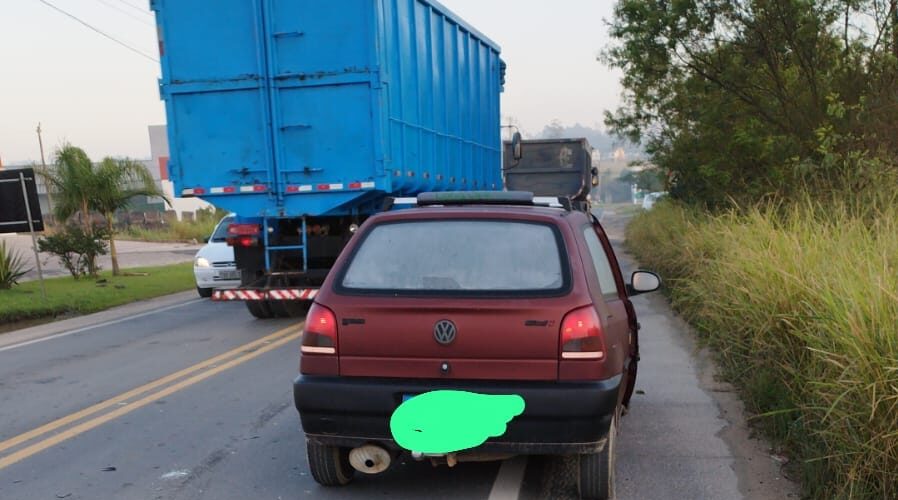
[503,139,598,208]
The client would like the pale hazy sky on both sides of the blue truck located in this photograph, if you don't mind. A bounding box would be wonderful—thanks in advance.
[0,0,621,164]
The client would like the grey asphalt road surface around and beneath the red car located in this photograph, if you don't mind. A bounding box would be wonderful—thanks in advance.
[0,213,794,500]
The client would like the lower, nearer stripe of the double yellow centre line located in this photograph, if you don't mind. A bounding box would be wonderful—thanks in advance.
[0,332,302,470]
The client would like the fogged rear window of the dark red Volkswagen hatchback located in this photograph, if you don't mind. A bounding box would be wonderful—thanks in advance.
[339,220,569,295]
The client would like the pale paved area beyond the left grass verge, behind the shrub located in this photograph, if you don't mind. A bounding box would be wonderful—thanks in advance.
[0,234,202,281]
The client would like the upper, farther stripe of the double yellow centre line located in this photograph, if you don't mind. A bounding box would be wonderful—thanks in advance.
[0,323,303,458]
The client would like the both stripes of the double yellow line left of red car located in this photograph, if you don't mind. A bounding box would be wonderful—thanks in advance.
[0,323,304,470]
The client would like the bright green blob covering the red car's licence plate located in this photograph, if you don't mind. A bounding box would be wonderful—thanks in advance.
[390,391,524,453]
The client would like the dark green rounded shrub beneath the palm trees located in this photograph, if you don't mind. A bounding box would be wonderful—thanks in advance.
[37,226,108,280]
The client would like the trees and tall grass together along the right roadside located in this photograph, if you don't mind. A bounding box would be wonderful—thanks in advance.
[604,0,898,499]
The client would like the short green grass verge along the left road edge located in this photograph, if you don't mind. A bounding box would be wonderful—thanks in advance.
[0,263,196,325]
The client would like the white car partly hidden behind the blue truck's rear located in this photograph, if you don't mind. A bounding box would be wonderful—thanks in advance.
[193,214,240,297]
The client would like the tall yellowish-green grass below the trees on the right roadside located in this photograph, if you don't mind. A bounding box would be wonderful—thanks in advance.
[627,198,898,499]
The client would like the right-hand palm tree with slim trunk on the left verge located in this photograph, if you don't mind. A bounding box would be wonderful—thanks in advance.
[90,158,168,276]
